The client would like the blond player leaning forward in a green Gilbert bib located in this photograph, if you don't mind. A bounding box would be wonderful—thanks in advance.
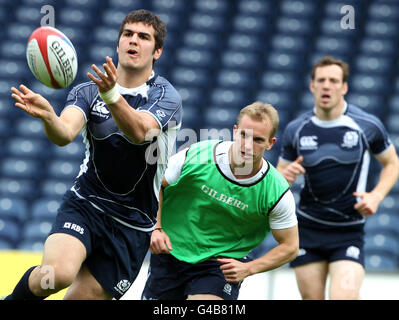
[142,102,298,300]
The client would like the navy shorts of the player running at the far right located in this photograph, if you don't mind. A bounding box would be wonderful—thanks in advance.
[290,216,364,268]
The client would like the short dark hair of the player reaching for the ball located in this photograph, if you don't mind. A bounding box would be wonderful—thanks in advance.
[118,9,166,50]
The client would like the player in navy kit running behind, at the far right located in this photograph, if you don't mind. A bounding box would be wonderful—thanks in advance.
[277,57,399,299]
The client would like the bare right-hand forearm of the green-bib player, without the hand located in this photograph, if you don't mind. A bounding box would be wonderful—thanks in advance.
[248,243,298,275]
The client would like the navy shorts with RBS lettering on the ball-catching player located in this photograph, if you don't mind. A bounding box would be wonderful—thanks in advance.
[49,191,150,299]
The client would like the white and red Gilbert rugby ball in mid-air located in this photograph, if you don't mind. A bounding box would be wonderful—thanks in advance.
[26,26,78,89]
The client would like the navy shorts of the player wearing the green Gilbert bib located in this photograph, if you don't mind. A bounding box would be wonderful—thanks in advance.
[141,254,249,300]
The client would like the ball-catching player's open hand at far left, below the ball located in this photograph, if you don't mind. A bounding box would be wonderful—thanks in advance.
[11,84,55,120]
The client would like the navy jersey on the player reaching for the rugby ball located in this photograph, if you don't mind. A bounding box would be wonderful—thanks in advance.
[64,73,182,231]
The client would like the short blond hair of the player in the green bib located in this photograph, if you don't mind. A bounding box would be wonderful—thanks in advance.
[237,101,280,138]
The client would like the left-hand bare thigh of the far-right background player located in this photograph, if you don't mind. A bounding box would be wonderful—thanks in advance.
[294,261,328,300]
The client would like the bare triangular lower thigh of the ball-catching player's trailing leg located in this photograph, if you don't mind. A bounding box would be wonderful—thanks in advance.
[64,264,112,300]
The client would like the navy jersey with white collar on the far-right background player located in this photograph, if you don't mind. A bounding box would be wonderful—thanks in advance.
[280,102,391,227]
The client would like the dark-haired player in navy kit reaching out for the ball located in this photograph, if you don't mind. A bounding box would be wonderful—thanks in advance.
[6,10,181,300]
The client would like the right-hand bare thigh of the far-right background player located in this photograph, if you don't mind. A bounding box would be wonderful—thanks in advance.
[329,260,365,300]
